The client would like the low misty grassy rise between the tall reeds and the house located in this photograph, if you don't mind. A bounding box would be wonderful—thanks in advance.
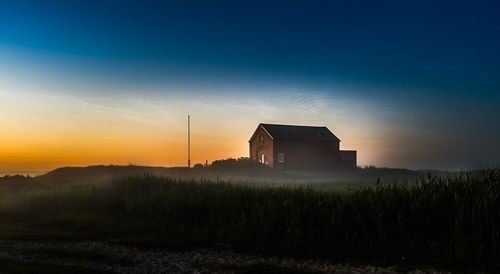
[0,159,426,185]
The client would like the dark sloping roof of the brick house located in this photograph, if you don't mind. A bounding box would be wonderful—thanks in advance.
[259,124,340,142]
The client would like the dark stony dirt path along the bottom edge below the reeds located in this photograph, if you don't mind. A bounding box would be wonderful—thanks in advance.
[0,240,446,274]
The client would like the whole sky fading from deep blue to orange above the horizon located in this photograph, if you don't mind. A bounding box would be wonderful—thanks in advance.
[0,0,500,174]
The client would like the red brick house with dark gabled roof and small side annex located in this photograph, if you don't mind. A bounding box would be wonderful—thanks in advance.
[249,124,357,169]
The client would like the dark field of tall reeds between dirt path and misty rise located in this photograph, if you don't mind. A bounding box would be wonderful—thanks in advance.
[0,169,500,271]
